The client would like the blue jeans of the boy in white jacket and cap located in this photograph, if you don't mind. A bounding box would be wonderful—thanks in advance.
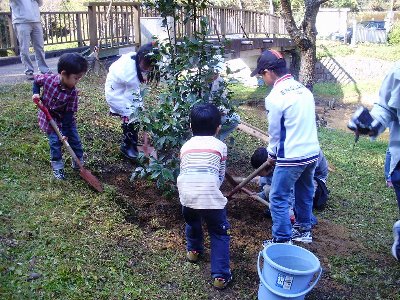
[269,162,316,241]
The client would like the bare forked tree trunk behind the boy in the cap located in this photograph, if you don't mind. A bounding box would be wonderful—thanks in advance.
[281,0,328,90]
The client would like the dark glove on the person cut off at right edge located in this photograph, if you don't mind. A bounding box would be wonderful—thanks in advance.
[347,106,382,137]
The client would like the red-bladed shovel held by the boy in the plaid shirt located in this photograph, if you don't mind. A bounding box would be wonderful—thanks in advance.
[33,98,103,192]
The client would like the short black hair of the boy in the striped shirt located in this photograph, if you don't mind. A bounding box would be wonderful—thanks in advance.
[190,103,221,136]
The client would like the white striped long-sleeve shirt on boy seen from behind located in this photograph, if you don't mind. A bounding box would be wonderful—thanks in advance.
[178,136,227,209]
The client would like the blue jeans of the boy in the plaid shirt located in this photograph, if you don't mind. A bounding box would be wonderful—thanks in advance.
[47,121,83,170]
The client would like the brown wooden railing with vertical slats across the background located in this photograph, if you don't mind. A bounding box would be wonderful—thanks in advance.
[0,2,287,53]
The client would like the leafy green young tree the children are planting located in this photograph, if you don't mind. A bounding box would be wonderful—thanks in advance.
[137,0,238,194]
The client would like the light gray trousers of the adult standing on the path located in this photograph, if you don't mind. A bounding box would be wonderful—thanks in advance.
[14,22,49,73]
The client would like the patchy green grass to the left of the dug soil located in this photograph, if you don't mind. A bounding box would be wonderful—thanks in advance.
[0,78,206,299]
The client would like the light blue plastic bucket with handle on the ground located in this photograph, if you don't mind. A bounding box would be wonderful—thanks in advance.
[257,243,322,300]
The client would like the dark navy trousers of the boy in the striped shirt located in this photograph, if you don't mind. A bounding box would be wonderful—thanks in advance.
[182,206,231,279]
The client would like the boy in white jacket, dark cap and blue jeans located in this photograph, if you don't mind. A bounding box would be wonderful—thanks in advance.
[251,50,320,243]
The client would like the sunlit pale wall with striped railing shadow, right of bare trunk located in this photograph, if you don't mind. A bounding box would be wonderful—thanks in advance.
[315,56,394,84]
